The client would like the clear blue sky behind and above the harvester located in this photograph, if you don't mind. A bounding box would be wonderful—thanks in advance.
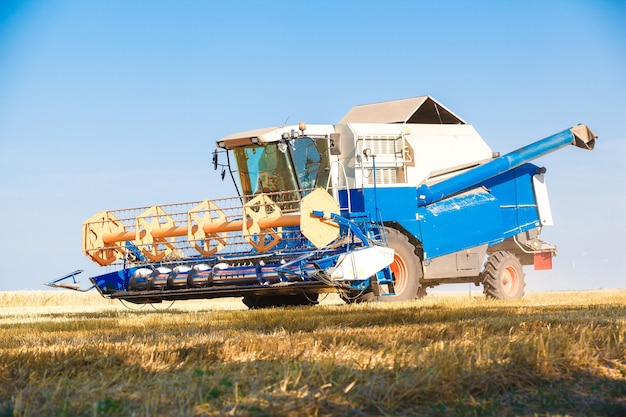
[0,0,626,291]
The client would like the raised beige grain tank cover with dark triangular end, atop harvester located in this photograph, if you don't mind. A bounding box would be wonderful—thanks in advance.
[339,96,465,125]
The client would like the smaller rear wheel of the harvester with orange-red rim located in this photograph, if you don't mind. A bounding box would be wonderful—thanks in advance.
[480,251,526,300]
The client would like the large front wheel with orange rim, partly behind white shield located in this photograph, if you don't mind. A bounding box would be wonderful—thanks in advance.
[352,227,426,302]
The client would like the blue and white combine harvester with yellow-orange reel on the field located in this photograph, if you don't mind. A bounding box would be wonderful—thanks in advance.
[48,96,596,308]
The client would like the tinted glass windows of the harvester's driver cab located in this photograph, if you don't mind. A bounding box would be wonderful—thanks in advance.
[233,137,329,201]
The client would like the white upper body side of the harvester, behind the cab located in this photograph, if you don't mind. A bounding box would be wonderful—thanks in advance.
[335,123,492,188]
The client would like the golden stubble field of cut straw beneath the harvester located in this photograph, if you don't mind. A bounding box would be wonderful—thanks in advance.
[0,290,626,416]
